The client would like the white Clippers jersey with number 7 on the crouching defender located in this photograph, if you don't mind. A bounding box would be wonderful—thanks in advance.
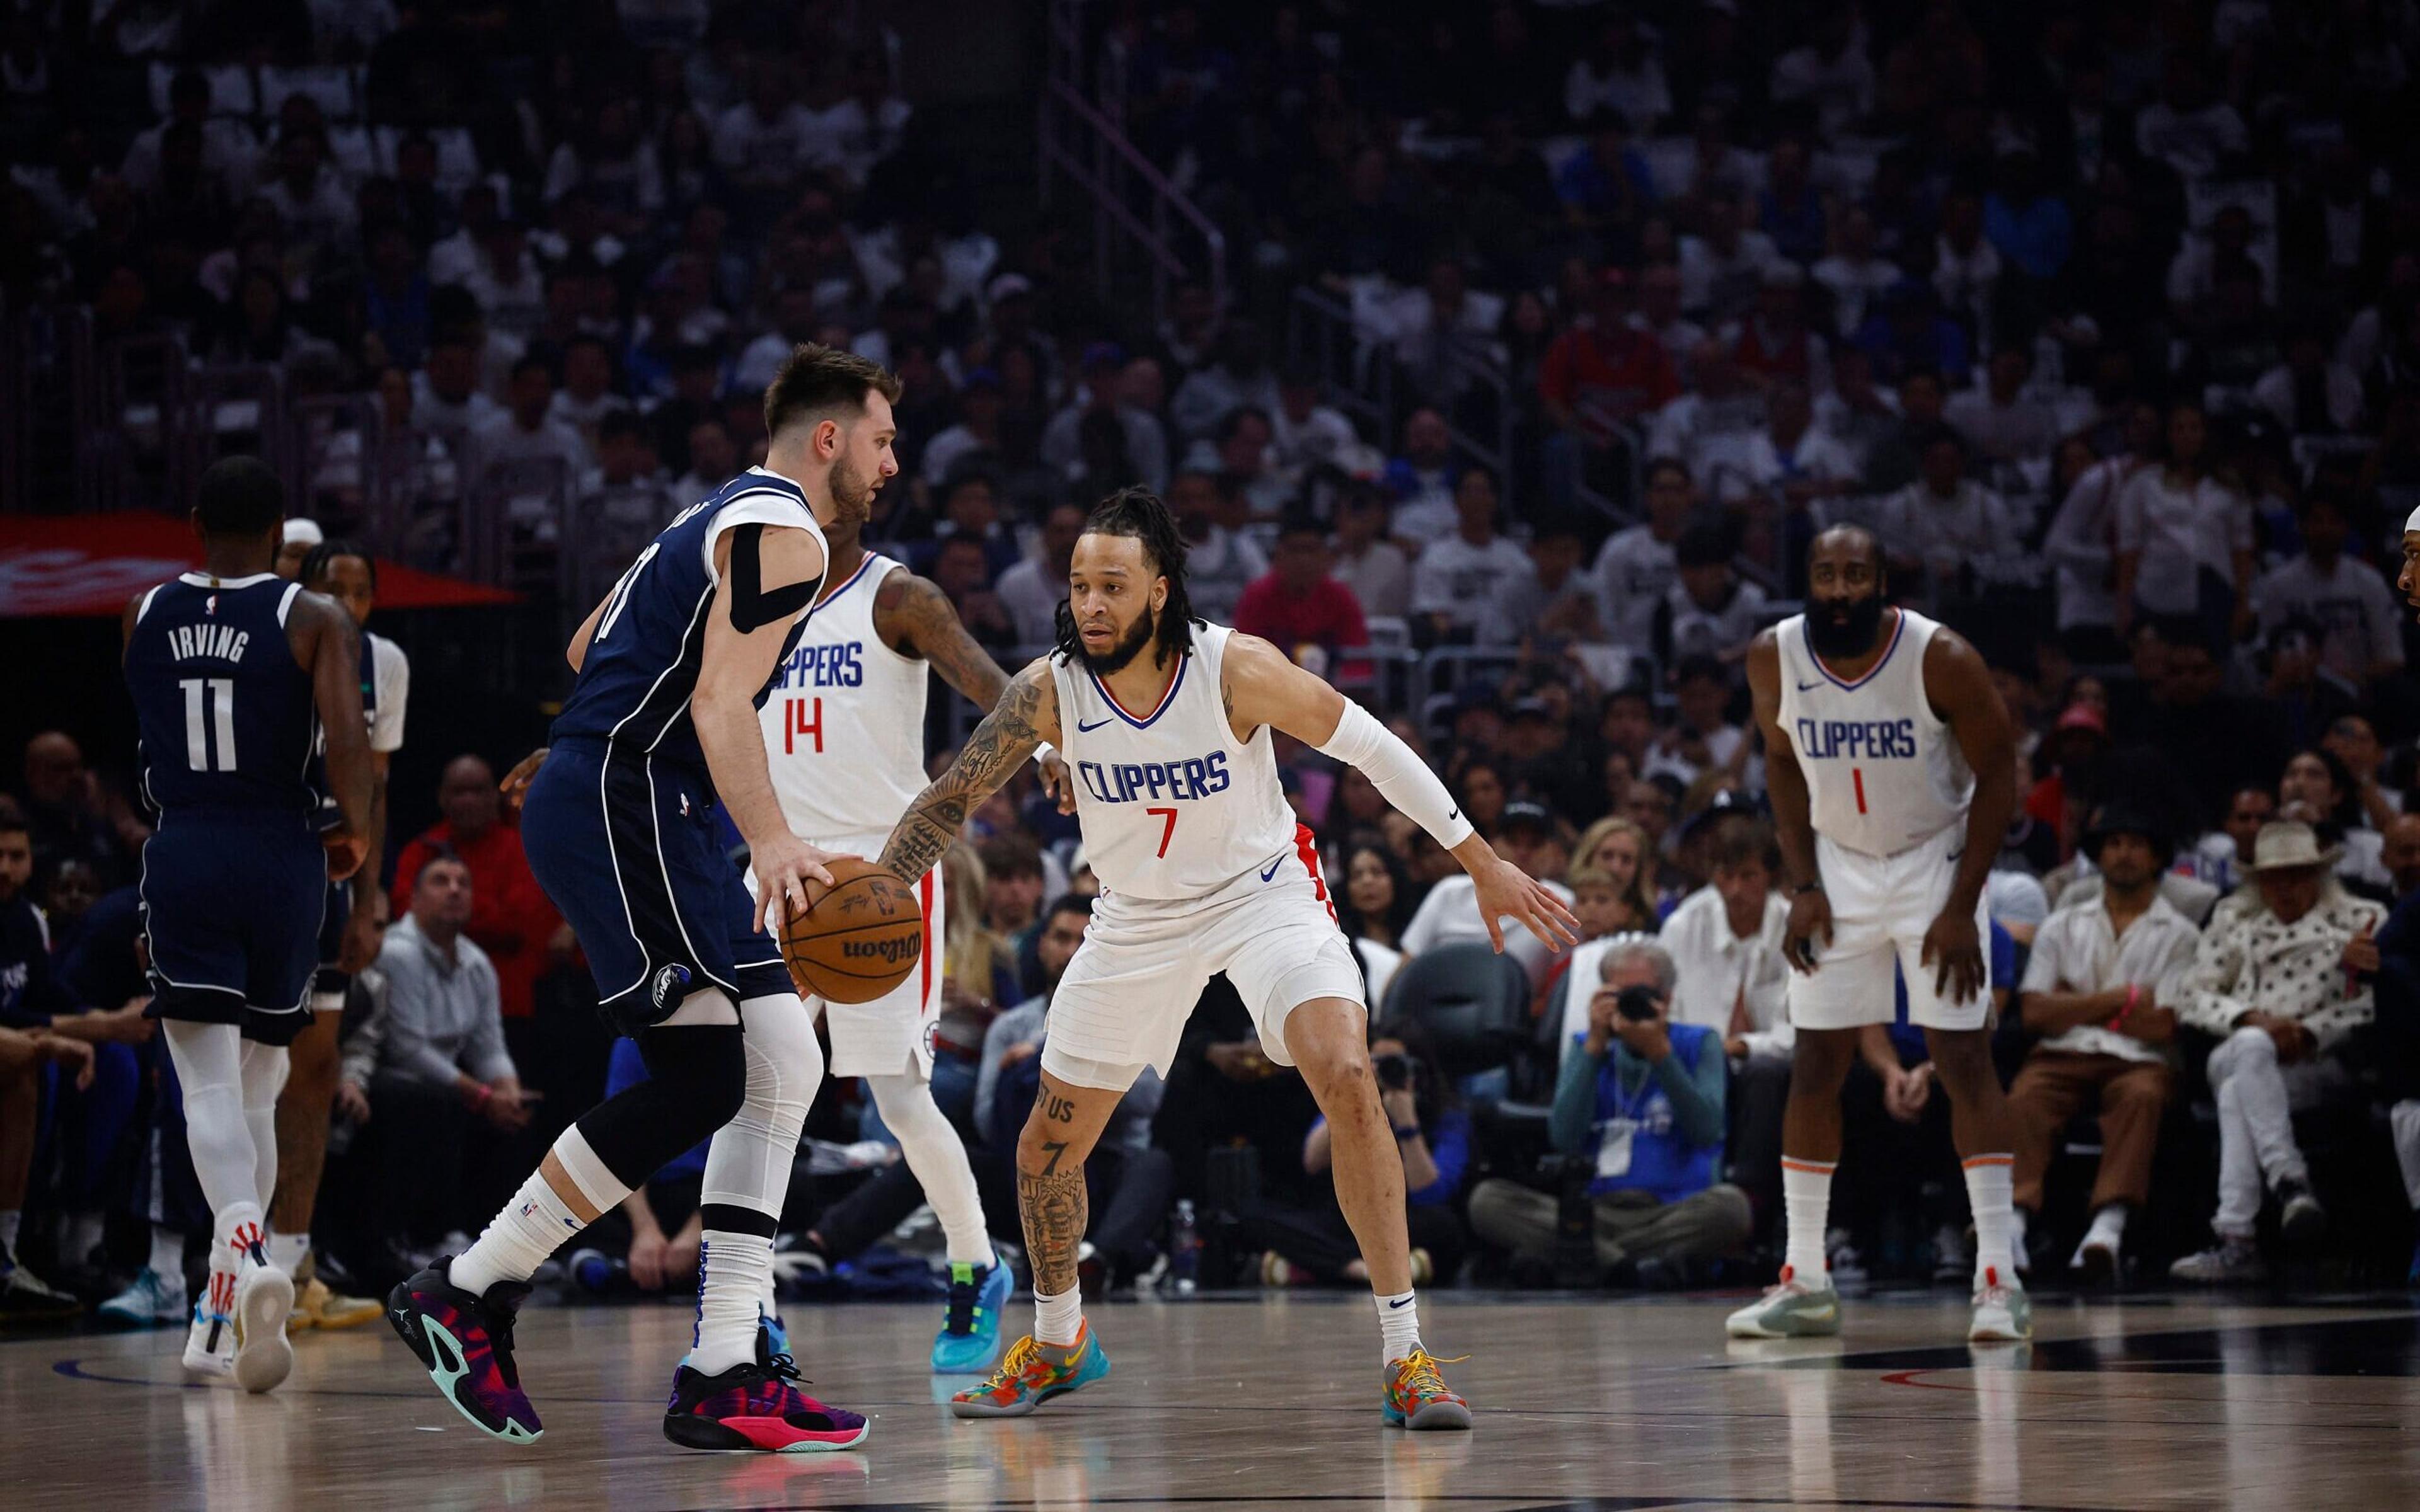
[1051,624,1294,900]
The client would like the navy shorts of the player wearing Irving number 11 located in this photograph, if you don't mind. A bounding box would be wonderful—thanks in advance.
[141,810,326,1045]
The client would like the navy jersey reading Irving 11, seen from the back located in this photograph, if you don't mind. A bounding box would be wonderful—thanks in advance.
[126,573,320,813]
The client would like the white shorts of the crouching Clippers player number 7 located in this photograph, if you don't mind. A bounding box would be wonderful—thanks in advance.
[1043,844,1368,1091]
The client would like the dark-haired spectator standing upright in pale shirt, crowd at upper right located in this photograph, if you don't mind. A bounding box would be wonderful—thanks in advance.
[2118,399,2253,641]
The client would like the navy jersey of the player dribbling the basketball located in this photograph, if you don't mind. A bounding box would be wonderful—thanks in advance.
[554,467,823,777]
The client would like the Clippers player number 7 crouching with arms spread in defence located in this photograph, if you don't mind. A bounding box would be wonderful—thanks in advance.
[884,489,1578,1428]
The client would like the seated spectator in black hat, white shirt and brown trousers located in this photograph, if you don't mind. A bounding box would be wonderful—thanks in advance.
[2008,806,2200,1280]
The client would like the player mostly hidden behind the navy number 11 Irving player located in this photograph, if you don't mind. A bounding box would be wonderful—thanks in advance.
[268,537,412,1328]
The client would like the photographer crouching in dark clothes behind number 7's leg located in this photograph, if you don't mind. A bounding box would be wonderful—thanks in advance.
[1242,1021,1472,1287]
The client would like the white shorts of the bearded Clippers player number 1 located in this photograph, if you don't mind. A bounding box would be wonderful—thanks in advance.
[1789,825,1991,1028]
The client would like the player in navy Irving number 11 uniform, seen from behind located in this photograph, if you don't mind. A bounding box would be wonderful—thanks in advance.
[124,457,371,1391]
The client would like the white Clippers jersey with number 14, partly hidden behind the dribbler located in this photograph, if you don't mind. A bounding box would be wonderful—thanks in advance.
[758,552,930,856]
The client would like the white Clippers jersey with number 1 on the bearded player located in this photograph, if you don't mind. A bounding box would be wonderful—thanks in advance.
[1774,610,1974,856]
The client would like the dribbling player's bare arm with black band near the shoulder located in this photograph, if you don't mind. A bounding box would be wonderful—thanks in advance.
[689,522,833,929]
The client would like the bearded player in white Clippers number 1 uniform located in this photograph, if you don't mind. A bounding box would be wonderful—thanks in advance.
[1728,525,2033,1340]
